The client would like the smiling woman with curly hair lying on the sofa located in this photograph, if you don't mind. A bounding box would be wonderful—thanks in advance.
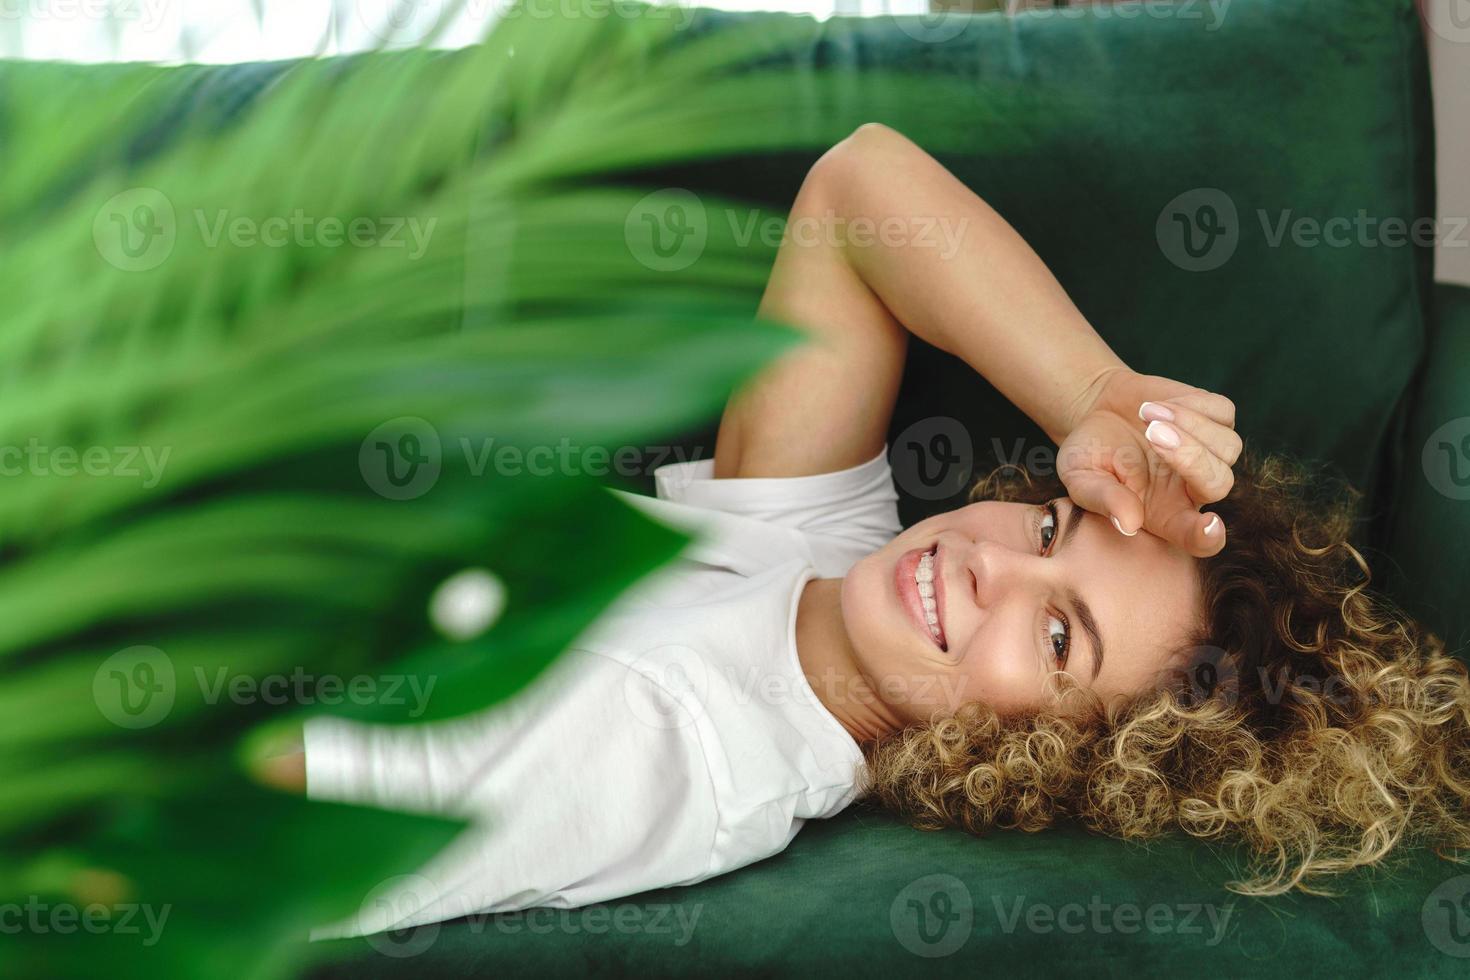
[262,125,1470,934]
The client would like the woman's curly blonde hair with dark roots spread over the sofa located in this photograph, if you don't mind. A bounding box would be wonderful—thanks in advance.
[864,453,1470,895]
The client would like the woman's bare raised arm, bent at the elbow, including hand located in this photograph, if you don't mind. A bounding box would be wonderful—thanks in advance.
[714,123,1239,554]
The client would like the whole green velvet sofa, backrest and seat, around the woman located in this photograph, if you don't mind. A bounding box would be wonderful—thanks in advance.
[34,0,1470,980]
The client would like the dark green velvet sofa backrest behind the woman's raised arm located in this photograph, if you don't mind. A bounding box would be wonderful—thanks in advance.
[635,0,1435,541]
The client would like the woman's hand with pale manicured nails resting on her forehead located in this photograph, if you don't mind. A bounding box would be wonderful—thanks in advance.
[1057,369,1242,558]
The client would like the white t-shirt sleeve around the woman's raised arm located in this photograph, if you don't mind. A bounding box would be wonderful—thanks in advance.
[654,447,903,551]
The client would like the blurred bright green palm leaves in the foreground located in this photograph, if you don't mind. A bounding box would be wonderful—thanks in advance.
[0,4,907,980]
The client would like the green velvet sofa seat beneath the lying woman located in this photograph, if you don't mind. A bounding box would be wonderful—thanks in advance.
[315,807,1470,980]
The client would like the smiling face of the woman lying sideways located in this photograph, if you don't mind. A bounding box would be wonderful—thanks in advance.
[842,497,1202,723]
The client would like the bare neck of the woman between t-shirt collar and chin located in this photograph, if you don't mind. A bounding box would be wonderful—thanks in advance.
[797,579,903,745]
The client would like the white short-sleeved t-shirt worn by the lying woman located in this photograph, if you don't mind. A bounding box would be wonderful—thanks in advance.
[306,453,900,937]
